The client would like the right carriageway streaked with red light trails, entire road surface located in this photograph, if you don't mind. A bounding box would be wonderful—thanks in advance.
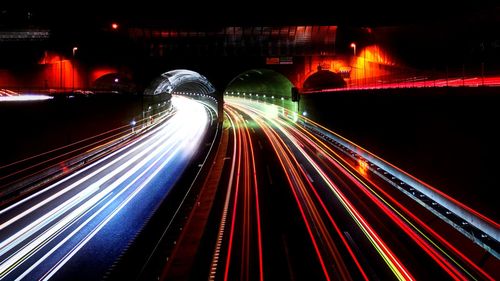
[210,96,500,280]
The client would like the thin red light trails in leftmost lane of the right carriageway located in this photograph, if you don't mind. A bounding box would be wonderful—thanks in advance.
[218,106,264,280]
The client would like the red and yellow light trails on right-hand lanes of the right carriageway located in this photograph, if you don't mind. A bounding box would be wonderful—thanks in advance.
[226,97,497,280]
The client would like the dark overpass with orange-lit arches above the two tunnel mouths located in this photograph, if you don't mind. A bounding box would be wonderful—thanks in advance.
[0,25,398,98]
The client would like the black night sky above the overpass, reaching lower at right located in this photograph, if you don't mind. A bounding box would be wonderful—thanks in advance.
[0,0,500,69]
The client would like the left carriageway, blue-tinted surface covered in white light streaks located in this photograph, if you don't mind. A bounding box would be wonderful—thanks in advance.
[0,96,211,280]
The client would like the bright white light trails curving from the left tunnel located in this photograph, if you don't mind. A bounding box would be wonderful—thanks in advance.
[0,97,209,279]
